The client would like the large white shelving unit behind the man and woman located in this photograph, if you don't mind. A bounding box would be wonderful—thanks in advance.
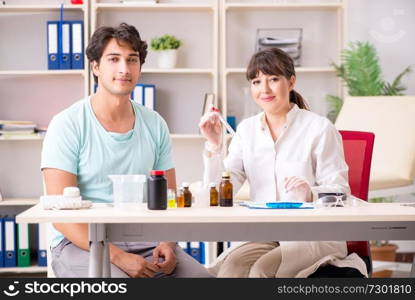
[0,0,352,272]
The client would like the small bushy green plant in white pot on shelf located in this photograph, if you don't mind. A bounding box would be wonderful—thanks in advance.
[150,34,182,69]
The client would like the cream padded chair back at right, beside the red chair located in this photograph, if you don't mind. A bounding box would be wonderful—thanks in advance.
[335,96,415,190]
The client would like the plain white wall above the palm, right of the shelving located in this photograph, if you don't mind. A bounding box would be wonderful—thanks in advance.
[346,0,415,95]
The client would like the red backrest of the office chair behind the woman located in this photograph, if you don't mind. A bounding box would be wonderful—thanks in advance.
[339,130,375,201]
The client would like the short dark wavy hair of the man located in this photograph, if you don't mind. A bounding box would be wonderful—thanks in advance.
[86,23,147,83]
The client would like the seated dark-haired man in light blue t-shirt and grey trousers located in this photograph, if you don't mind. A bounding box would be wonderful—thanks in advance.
[41,23,210,277]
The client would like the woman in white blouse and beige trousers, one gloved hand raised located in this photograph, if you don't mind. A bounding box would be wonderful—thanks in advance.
[199,48,367,277]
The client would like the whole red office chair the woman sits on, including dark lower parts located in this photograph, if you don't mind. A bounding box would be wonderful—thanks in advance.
[312,130,375,277]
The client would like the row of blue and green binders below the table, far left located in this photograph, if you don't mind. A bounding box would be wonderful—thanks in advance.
[0,216,47,268]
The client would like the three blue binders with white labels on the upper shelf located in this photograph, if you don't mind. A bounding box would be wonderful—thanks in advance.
[47,20,84,70]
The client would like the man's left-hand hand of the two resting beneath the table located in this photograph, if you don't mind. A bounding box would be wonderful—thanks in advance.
[114,251,161,278]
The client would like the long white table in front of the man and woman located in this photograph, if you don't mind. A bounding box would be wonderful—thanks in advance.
[16,203,415,277]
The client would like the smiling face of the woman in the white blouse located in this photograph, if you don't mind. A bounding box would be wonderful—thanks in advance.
[251,71,295,113]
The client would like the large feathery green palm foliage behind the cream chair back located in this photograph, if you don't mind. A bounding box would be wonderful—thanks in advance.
[326,41,412,123]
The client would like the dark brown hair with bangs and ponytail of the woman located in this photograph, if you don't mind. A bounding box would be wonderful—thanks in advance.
[246,48,309,110]
